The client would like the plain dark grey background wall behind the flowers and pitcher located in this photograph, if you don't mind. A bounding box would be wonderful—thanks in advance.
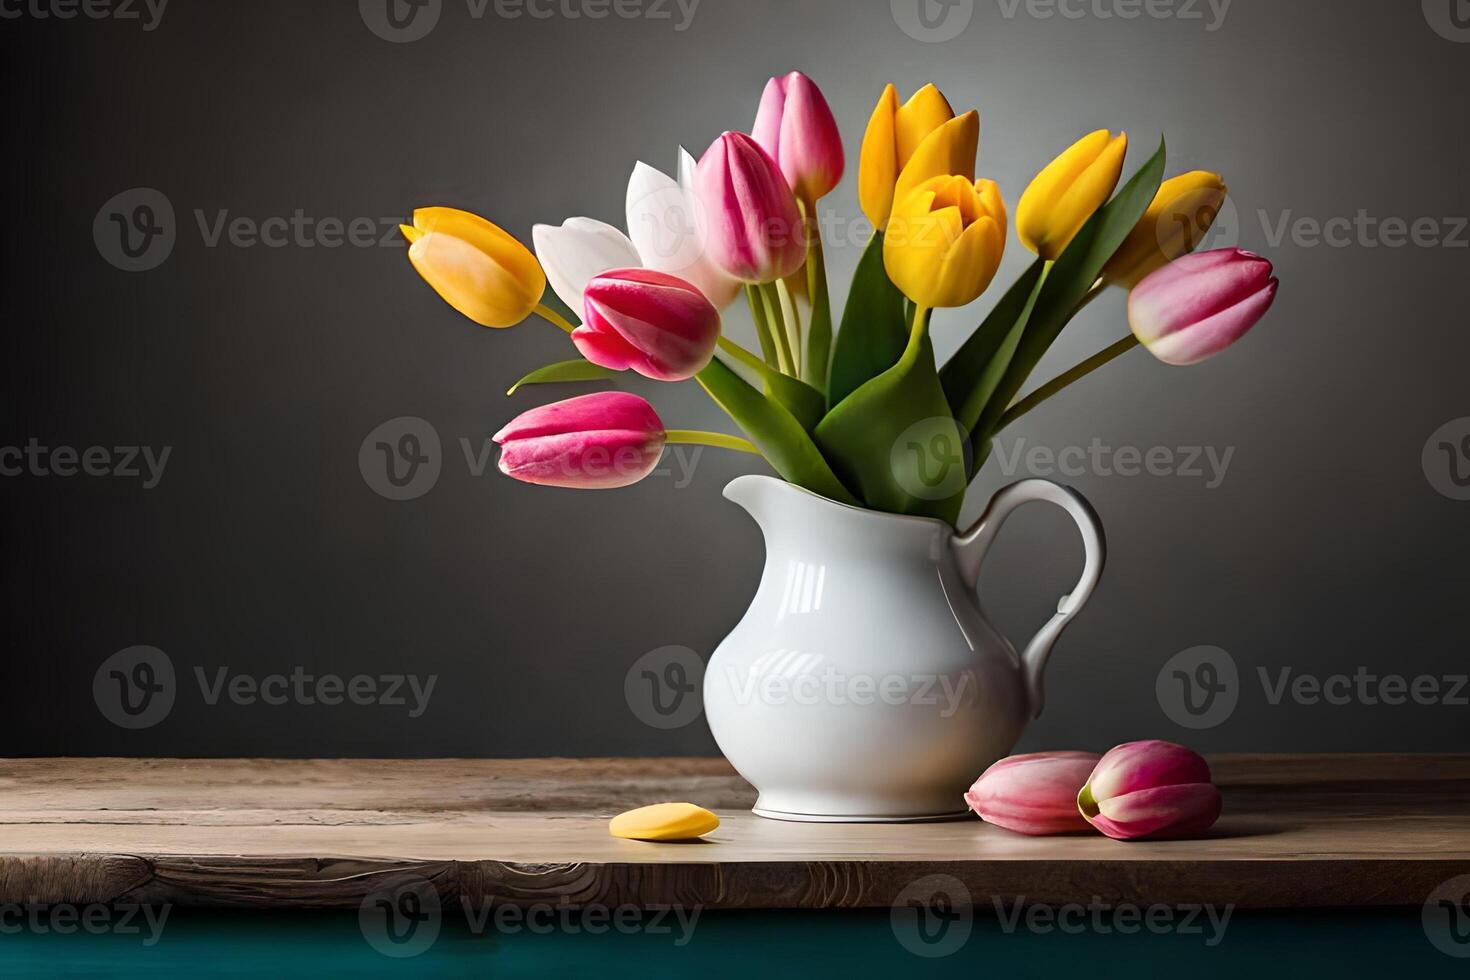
[0,0,1470,755]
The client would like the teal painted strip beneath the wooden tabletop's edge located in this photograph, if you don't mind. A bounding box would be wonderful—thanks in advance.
[0,909,1470,980]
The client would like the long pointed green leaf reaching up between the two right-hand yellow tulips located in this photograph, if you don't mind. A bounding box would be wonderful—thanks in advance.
[973,140,1166,452]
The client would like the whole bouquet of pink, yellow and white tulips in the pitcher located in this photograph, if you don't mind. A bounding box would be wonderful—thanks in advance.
[403,72,1277,523]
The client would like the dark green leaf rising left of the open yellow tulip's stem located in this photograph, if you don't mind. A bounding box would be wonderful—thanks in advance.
[828,232,908,406]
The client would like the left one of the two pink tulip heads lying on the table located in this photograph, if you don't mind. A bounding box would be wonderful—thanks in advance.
[964,752,1101,836]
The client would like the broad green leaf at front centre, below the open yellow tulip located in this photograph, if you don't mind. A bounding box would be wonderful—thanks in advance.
[816,318,969,525]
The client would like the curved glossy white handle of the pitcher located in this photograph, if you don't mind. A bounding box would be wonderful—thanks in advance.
[956,480,1107,717]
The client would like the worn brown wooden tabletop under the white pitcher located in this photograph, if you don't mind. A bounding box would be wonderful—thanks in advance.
[0,755,1470,908]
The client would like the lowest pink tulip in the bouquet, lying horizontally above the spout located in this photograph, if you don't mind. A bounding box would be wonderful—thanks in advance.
[495,391,664,489]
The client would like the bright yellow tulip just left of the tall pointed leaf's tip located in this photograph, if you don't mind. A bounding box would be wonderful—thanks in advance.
[1016,129,1127,260]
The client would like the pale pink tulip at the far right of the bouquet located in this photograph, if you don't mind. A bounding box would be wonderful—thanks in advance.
[1127,248,1280,364]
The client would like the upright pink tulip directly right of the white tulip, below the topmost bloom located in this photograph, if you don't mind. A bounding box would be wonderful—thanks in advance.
[694,132,807,282]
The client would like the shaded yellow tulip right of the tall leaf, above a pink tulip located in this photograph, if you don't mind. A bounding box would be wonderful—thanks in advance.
[1103,170,1229,289]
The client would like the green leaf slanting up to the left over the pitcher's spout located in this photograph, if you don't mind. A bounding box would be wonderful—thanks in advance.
[695,360,857,504]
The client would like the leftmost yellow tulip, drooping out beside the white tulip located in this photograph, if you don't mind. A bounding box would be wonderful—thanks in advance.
[400,207,547,326]
